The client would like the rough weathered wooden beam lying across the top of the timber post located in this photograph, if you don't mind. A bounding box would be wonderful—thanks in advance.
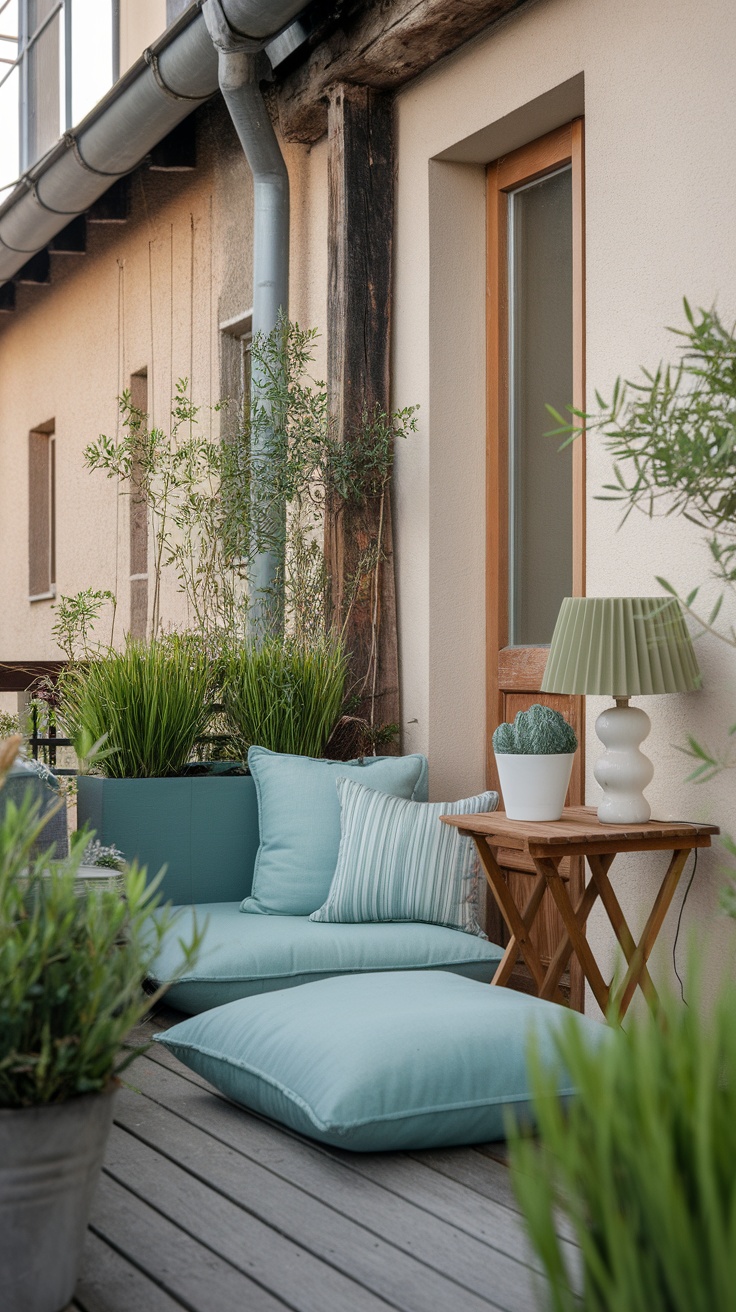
[278,0,526,142]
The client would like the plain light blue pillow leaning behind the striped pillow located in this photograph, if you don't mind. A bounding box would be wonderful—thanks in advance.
[243,747,426,916]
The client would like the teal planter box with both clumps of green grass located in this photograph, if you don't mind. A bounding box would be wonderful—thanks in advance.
[65,635,348,904]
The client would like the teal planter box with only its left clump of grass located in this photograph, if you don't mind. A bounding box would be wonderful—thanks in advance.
[59,634,258,904]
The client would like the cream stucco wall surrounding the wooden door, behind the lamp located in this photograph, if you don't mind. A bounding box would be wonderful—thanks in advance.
[394,0,736,1007]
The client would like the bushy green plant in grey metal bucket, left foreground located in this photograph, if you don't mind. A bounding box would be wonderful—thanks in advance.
[0,736,198,1312]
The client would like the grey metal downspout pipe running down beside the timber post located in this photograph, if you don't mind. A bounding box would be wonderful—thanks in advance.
[202,0,289,638]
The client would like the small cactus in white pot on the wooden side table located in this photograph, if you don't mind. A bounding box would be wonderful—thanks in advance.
[493,702,577,820]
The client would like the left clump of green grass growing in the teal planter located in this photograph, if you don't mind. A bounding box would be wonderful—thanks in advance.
[59,634,213,779]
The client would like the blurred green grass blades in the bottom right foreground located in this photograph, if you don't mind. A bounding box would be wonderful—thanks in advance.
[510,972,736,1312]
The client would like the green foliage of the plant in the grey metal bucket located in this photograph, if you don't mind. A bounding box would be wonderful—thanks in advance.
[0,762,199,1107]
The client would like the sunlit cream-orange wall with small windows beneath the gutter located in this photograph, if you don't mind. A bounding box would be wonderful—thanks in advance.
[0,104,252,660]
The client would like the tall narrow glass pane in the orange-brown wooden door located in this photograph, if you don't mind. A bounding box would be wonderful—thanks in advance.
[508,168,572,647]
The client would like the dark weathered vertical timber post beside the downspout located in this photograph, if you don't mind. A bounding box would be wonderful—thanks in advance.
[325,85,399,750]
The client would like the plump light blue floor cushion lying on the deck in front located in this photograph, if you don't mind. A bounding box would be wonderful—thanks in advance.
[156,970,603,1152]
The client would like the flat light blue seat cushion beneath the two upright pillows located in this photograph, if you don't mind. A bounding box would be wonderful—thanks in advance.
[155,903,502,1014]
